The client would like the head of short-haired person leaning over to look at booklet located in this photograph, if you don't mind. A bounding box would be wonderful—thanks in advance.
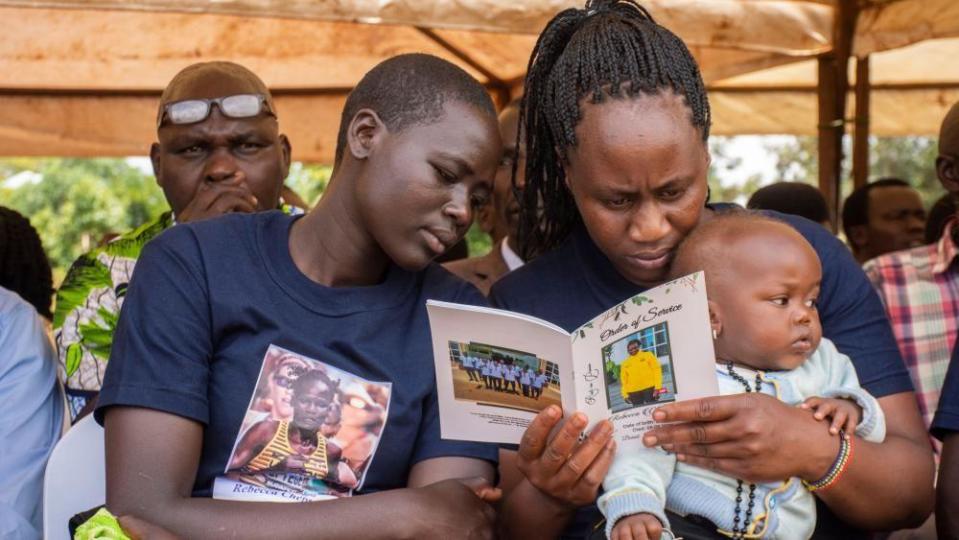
[331,54,501,270]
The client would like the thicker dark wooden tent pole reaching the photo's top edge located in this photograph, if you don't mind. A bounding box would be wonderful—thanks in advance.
[818,0,859,232]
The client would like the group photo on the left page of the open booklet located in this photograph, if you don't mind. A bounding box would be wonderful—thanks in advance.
[449,341,562,413]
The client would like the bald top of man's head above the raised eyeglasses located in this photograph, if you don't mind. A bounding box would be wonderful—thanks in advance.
[157,62,276,125]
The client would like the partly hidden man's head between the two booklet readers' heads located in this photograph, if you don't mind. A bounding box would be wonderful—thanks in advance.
[476,100,526,247]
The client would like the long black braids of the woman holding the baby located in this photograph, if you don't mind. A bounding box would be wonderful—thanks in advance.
[514,0,710,260]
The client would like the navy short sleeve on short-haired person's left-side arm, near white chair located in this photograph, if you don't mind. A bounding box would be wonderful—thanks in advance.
[95,226,213,424]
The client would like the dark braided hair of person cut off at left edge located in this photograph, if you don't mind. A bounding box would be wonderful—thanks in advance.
[0,206,53,320]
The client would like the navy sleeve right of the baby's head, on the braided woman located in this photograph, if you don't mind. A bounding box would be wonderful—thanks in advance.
[775,214,913,398]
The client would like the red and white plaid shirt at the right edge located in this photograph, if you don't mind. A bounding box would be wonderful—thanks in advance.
[863,221,959,427]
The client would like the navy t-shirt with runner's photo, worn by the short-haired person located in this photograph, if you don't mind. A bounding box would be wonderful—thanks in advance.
[96,212,497,496]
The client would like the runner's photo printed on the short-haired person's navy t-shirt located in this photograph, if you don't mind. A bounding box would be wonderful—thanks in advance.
[213,345,392,502]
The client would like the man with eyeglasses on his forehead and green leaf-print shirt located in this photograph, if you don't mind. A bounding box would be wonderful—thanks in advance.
[53,62,300,421]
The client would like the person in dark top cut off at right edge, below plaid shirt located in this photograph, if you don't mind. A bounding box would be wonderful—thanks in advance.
[930,343,959,539]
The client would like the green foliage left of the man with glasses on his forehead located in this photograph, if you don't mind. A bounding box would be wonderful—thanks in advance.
[0,158,167,278]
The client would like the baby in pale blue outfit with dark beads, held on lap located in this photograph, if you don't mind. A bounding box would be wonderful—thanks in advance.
[598,212,885,540]
